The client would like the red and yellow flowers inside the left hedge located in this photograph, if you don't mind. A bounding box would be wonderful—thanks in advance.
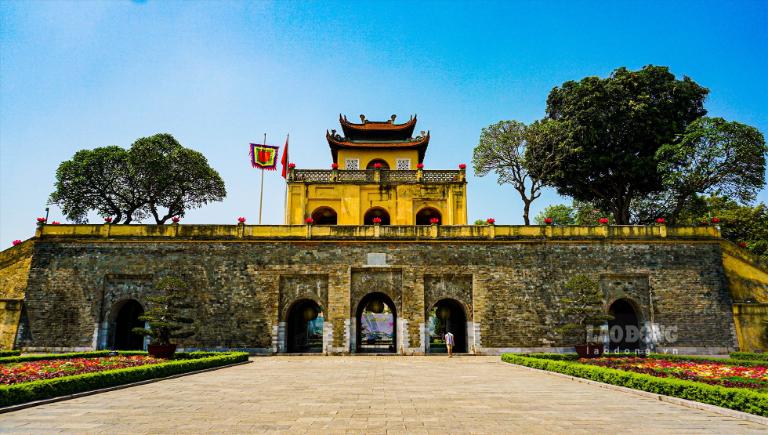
[0,355,163,385]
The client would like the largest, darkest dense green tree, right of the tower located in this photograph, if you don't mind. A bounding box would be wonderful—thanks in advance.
[525,66,708,224]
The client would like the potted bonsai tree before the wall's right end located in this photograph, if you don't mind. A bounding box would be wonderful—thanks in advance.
[556,275,613,358]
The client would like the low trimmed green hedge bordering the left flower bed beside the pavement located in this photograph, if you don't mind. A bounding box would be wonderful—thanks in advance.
[0,352,248,406]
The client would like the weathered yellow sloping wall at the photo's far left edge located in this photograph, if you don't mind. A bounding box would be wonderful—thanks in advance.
[0,241,33,349]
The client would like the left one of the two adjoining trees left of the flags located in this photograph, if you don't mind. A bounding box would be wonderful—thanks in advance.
[49,146,145,223]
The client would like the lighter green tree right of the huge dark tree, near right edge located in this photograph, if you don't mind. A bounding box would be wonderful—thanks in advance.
[656,117,768,223]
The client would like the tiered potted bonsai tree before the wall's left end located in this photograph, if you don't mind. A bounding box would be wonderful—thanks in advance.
[133,276,195,359]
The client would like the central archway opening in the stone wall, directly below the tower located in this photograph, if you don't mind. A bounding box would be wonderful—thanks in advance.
[357,293,397,353]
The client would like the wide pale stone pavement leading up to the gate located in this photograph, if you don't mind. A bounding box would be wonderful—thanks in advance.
[0,356,768,434]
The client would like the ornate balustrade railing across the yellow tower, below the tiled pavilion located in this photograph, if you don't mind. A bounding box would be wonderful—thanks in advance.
[288,169,466,184]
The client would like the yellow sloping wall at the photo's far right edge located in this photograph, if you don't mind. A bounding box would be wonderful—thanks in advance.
[721,241,768,351]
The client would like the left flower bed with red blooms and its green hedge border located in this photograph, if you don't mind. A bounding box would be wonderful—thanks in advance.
[0,352,248,407]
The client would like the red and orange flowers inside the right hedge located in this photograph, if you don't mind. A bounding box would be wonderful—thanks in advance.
[579,357,768,392]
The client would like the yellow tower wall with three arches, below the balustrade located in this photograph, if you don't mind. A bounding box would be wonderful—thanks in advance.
[285,183,467,225]
